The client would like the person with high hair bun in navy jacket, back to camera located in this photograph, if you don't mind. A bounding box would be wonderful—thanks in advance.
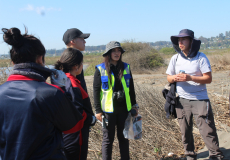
[0,28,84,160]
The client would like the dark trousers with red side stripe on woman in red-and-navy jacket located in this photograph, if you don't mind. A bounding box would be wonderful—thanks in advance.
[63,126,89,160]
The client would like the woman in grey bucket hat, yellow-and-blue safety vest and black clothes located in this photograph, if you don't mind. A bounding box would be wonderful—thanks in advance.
[93,41,138,160]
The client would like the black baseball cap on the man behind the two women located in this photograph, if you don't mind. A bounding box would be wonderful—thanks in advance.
[63,28,90,45]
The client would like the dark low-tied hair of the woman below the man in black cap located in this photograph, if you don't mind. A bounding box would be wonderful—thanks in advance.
[54,48,83,73]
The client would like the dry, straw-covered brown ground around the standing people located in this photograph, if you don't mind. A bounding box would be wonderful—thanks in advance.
[85,71,230,159]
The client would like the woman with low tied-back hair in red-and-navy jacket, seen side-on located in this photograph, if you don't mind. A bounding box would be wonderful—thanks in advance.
[52,48,96,160]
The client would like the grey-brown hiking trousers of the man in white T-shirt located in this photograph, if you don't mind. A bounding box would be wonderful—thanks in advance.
[176,98,222,159]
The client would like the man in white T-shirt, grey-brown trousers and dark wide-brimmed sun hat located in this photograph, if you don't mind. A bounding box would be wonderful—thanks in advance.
[166,29,223,160]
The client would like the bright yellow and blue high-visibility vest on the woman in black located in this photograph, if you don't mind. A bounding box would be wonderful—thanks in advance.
[96,63,132,113]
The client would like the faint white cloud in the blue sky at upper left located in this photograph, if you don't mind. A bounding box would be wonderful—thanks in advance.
[20,4,61,15]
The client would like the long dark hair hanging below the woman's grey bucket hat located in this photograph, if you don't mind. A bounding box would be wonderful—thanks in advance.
[104,49,124,83]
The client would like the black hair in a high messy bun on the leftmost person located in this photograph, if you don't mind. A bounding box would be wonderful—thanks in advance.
[2,28,46,64]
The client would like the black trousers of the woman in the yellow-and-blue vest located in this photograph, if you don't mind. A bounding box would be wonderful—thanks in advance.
[102,108,129,160]
